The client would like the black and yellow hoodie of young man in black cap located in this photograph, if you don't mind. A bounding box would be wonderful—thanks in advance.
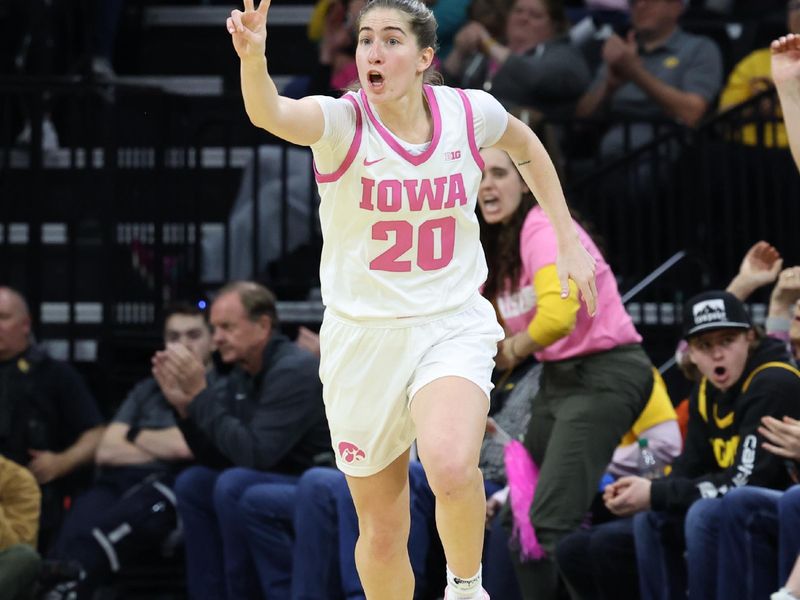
[650,338,800,512]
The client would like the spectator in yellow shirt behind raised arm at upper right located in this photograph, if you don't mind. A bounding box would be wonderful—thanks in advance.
[719,0,800,148]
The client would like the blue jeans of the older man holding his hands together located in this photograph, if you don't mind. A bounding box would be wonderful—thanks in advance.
[175,467,297,600]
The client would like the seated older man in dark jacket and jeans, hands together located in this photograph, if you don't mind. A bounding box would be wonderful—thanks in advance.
[153,282,330,600]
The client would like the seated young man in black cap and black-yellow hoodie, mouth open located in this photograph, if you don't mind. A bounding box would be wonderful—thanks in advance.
[592,291,800,600]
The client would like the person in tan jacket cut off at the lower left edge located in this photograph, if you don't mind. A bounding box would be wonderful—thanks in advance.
[0,456,41,600]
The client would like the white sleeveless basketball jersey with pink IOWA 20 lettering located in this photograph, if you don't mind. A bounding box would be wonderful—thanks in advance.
[312,85,500,319]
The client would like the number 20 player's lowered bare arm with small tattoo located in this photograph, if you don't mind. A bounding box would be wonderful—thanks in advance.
[495,115,597,315]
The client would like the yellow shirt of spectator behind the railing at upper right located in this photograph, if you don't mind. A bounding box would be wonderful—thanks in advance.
[719,48,789,148]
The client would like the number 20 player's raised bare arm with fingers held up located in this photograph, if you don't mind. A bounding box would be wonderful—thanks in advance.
[227,0,325,146]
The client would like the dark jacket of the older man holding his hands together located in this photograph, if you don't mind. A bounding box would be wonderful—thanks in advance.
[178,333,331,474]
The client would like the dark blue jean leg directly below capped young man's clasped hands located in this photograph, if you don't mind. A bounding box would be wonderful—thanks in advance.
[633,511,686,600]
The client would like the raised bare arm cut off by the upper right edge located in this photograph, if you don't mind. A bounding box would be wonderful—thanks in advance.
[770,32,800,169]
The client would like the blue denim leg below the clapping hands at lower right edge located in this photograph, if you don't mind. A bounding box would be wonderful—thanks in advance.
[718,487,780,600]
